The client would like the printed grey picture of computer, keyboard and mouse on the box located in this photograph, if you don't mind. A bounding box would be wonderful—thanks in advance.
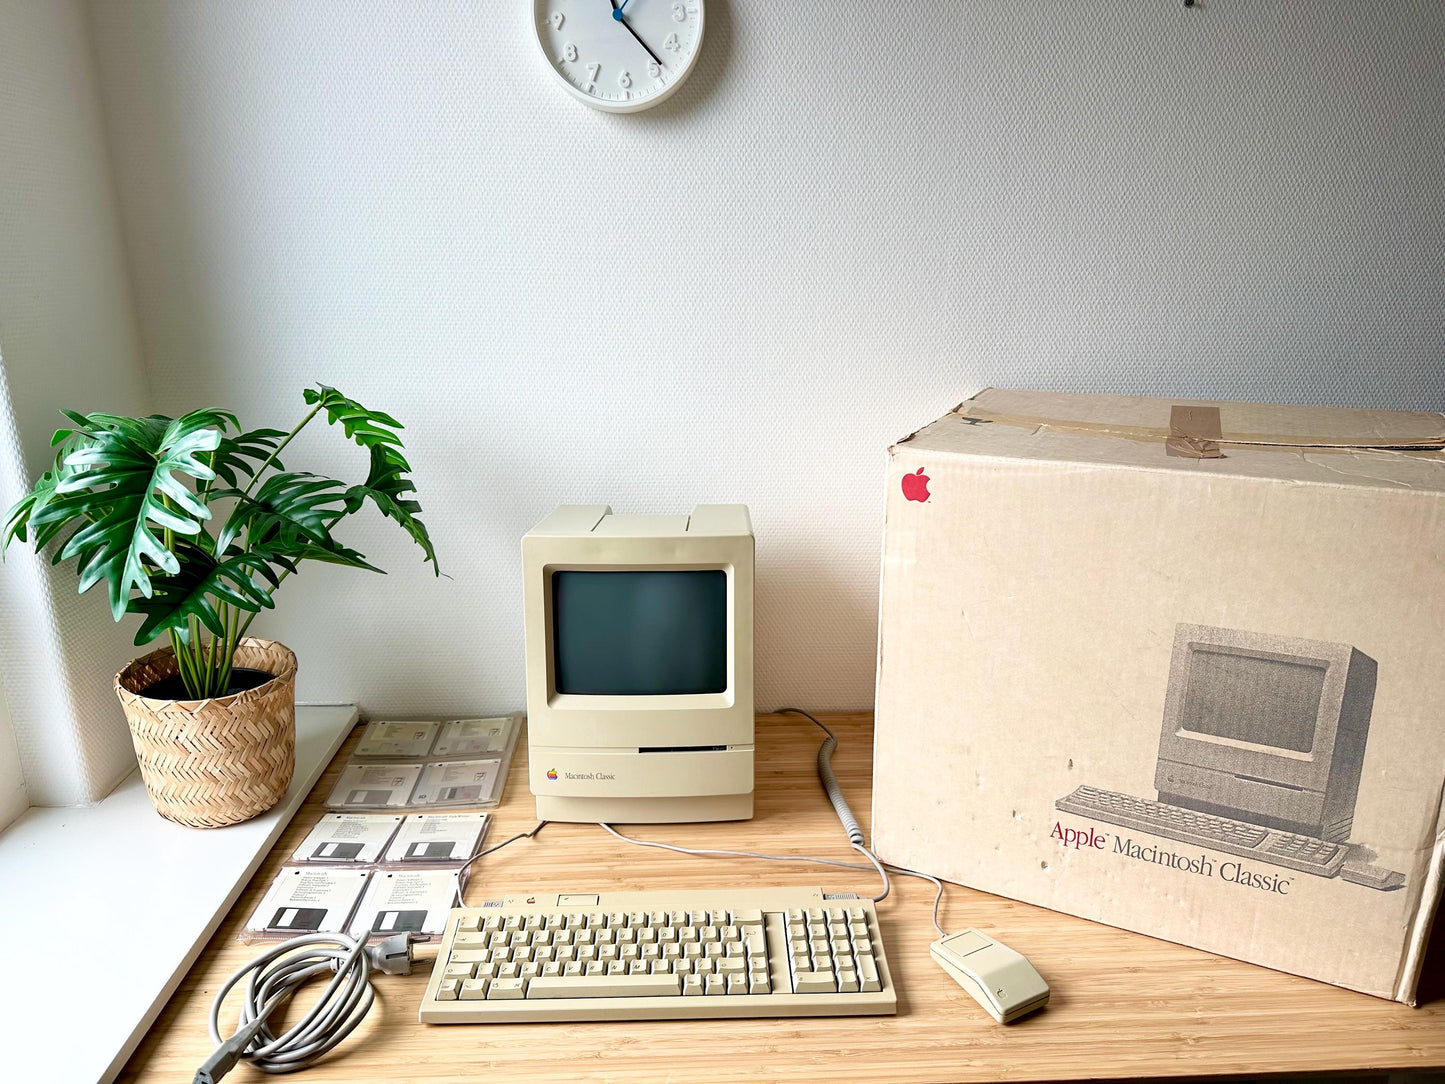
[1055,624,1405,890]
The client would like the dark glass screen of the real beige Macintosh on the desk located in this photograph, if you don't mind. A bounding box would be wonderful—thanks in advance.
[552,568,730,697]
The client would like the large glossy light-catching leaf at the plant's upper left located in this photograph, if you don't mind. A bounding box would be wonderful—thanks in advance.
[43,409,234,620]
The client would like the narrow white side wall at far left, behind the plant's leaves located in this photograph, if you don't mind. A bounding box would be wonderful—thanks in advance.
[0,0,147,805]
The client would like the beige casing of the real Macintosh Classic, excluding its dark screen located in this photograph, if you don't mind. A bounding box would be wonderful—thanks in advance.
[522,504,753,824]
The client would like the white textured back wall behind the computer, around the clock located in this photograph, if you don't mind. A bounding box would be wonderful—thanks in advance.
[84,0,1445,711]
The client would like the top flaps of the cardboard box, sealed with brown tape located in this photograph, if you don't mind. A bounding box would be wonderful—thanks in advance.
[954,387,1445,451]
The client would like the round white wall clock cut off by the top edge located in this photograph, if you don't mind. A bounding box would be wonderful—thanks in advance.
[532,0,702,113]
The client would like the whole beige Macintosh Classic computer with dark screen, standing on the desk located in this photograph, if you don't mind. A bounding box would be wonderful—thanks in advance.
[522,504,753,824]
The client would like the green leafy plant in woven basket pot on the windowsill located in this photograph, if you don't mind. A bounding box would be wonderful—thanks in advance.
[0,384,439,828]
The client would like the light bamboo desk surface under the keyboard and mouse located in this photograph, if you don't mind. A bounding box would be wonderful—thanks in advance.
[120,714,1445,1084]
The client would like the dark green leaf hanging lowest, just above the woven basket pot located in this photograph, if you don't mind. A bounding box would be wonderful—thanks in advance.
[130,542,279,645]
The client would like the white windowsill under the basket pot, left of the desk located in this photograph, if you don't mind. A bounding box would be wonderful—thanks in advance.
[0,705,357,1081]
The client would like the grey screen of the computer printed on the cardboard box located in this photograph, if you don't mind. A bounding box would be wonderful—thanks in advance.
[1179,645,1328,753]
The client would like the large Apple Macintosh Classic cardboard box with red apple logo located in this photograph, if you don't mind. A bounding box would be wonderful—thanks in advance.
[873,390,1445,1003]
